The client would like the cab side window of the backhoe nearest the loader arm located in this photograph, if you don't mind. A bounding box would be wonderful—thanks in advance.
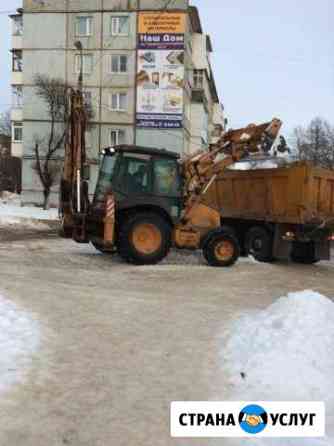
[154,159,181,197]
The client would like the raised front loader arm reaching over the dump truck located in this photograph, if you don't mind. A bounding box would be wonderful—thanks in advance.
[174,119,282,248]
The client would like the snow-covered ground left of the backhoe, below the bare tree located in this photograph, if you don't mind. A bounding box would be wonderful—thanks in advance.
[0,192,58,230]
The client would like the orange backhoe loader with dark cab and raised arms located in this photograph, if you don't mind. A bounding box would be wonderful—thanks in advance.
[60,90,282,267]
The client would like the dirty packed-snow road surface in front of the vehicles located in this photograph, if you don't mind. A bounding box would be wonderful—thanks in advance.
[0,234,334,446]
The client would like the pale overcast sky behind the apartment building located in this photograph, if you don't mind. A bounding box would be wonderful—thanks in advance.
[0,0,334,132]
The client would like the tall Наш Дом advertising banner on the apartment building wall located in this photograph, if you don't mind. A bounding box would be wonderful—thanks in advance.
[137,13,185,129]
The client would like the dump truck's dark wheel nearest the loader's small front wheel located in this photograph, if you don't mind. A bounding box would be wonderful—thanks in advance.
[246,226,274,263]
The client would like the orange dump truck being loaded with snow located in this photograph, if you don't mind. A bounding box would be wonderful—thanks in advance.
[204,161,334,264]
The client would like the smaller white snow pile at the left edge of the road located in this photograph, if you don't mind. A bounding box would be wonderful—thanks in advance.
[0,296,40,392]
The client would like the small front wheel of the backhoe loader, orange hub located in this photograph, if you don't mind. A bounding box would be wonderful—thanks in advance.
[203,232,240,267]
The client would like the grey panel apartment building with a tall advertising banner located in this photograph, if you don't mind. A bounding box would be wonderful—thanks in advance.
[11,0,224,203]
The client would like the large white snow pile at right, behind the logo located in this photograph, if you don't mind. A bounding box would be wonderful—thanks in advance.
[222,291,334,446]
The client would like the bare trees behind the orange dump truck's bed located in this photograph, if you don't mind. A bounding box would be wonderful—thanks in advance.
[294,118,334,169]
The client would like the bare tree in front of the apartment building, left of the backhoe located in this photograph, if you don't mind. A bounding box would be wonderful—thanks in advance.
[33,75,93,209]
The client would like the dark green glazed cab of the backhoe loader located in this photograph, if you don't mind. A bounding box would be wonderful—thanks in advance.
[92,145,183,222]
